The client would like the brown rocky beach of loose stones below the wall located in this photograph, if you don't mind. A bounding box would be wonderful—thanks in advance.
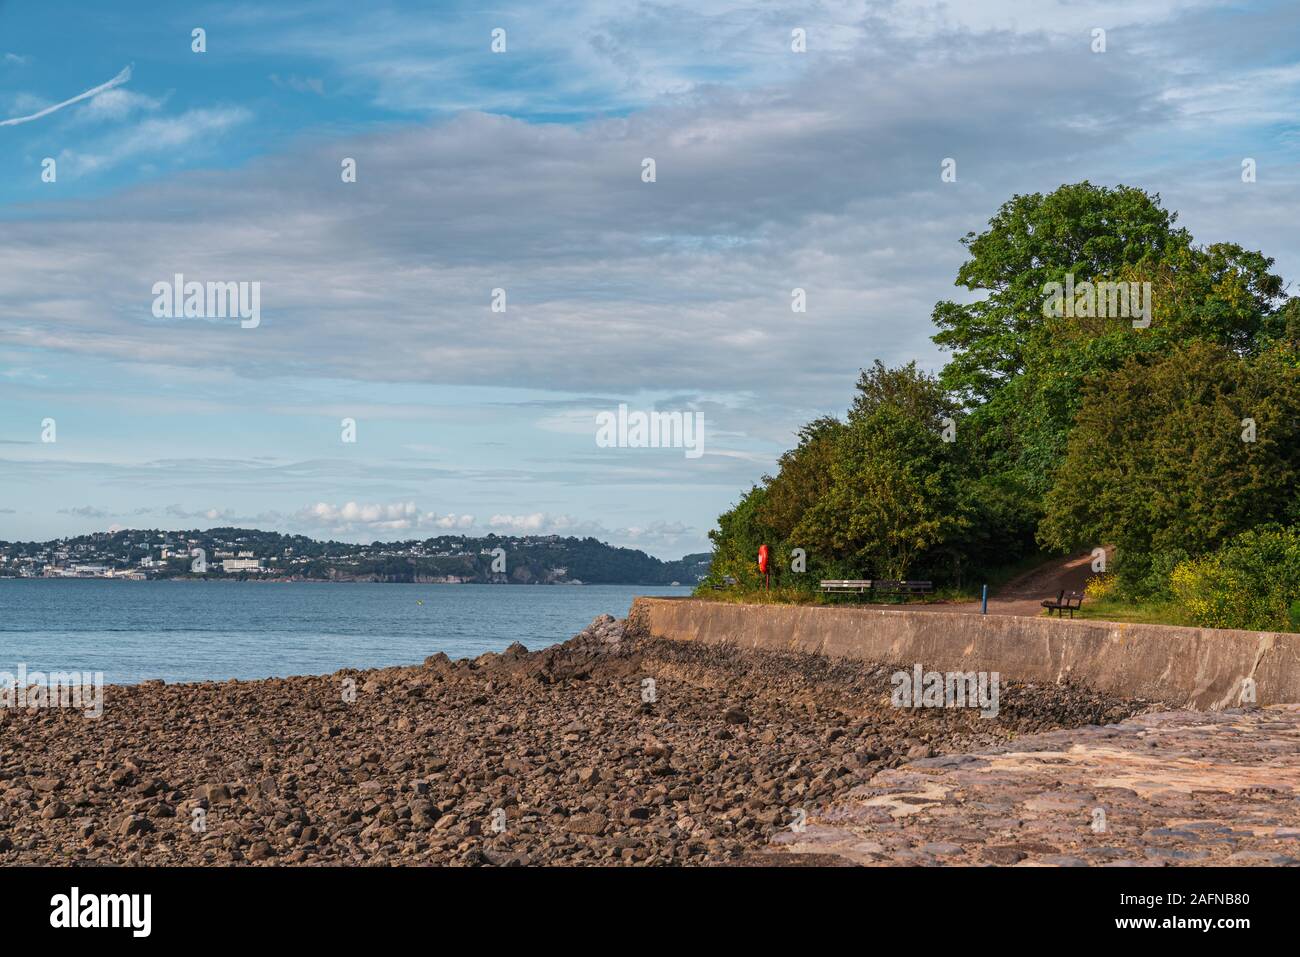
[0,616,1153,865]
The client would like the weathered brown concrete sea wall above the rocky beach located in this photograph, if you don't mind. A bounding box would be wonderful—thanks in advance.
[628,598,1300,710]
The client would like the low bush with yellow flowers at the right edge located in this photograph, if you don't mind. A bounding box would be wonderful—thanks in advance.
[1170,525,1300,632]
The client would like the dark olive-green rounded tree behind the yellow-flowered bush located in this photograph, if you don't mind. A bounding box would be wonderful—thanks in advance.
[1039,342,1300,597]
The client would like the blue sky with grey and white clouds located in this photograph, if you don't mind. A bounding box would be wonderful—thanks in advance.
[0,0,1300,558]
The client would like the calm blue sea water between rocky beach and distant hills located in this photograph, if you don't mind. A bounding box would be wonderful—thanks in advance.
[0,579,690,684]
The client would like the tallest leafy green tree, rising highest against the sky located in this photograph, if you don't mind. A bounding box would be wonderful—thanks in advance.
[933,182,1286,516]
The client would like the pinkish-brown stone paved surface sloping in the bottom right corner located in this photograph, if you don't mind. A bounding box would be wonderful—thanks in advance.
[763,705,1300,867]
